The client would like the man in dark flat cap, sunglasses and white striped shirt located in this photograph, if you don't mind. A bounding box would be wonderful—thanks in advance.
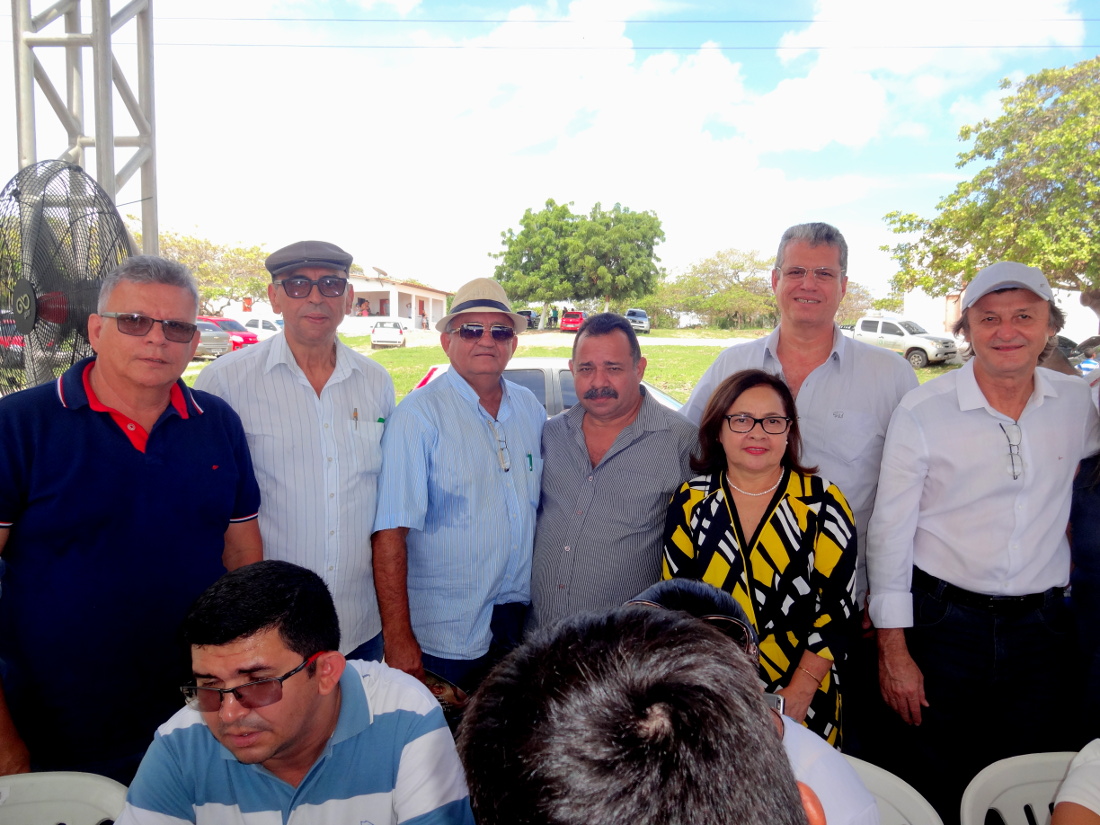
[195,241,394,660]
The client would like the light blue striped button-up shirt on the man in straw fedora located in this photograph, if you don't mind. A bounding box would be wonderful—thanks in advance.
[374,370,546,659]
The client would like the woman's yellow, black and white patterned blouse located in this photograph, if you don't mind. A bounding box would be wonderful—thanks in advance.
[663,470,856,747]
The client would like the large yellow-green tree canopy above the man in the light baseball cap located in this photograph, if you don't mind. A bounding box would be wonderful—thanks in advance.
[883,57,1100,295]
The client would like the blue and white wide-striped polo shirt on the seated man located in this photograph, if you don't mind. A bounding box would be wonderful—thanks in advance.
[118,661,473,825]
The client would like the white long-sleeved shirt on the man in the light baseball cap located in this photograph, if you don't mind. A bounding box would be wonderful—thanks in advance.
[868,361,1100,627]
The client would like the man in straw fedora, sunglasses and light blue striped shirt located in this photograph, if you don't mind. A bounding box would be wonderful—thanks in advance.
[373,278,546,690]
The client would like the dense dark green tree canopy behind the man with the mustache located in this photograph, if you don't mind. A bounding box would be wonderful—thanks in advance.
[490,199,664,316]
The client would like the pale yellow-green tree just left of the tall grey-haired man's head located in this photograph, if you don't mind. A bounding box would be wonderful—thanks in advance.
[666,249,777,329]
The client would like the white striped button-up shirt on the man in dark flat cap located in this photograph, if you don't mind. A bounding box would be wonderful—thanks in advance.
[195,334,394,653]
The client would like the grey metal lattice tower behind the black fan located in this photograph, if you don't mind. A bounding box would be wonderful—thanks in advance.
[11,0,158,255]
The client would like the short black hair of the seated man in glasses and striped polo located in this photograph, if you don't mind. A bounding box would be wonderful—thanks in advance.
[179,559,340,658]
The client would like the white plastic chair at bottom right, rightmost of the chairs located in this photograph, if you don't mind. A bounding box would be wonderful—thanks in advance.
[960,751,1077,825]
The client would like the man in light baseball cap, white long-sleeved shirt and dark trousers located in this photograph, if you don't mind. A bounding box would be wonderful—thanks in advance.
[867,262,1100,825]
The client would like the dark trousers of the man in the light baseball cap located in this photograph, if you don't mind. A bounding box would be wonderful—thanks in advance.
[893,580,1087,825]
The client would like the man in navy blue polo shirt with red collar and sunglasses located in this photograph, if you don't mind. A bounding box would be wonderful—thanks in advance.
[0,256,262,782]
